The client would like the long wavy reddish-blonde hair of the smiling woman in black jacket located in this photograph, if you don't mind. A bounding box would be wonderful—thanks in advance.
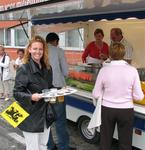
[23,35,50,69]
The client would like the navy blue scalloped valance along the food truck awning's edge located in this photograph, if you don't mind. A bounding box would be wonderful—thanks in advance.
[31,11,145,25]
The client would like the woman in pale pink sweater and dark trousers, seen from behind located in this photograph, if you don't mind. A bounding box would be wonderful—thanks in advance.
[93,43,144,150]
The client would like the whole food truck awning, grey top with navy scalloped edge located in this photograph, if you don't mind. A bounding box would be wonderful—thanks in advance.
[32,0,145,25]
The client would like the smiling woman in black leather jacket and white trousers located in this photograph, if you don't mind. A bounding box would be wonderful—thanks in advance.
[14,36,52,150]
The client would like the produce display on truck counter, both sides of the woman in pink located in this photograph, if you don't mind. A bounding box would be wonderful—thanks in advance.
[66,65,145,105]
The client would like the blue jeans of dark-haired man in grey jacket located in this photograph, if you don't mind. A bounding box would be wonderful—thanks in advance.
[47,102,69,150]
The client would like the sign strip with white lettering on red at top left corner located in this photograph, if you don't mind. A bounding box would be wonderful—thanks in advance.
[0,0,49,11]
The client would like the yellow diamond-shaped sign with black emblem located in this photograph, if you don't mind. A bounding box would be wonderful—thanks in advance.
[1,102,29,128]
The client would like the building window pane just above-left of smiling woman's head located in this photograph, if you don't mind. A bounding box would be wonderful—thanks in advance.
[14,25,28,46]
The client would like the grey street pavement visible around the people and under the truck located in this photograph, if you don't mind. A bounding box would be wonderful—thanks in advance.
[0,99,140,150]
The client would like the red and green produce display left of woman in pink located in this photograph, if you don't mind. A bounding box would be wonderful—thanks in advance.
[66,64,101,92]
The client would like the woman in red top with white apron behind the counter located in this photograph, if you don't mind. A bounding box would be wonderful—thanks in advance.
[82,28,109,64]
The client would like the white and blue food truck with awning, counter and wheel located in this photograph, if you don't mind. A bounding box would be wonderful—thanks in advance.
[0,0,145,149]
